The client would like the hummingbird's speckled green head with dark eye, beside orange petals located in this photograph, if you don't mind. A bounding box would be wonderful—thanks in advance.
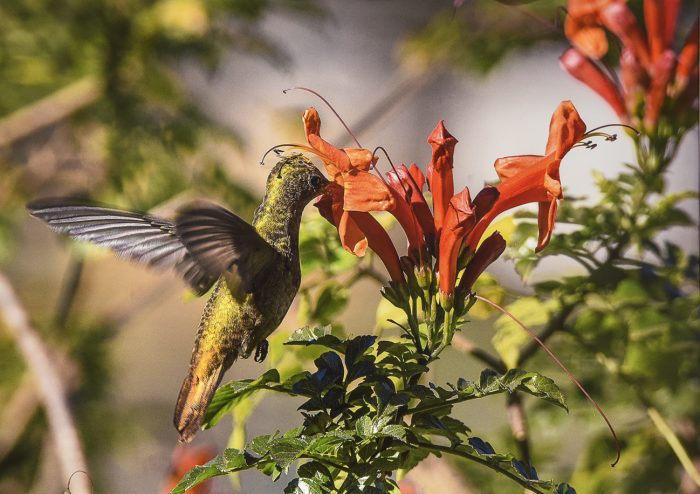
[265,154,330,209]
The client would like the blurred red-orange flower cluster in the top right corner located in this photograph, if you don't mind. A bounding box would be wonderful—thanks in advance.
[560,0,698,131]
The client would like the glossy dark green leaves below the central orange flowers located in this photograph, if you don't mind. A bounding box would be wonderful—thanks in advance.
[173,327,574,493]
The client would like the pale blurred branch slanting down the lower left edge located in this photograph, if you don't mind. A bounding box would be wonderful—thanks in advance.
[0,274,92,494]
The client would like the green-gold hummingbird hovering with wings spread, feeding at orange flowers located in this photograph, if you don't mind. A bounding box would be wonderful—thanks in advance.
[27,154,329,442]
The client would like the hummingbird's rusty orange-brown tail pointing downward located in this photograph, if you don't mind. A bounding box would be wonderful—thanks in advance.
[173,352,235,443]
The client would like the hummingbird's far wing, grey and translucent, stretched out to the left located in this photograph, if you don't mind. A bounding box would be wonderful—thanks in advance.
[27,199,218,295]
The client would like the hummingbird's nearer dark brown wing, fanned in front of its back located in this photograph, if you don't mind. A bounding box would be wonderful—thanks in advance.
[175,202,279,299]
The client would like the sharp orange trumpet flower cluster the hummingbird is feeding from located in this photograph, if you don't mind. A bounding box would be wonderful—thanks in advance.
[303,101,586,306]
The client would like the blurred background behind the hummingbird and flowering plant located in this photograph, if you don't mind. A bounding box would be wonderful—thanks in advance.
[0,0,699,493]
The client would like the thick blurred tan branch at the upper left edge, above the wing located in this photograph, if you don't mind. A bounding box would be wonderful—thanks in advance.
[0,77,102,148]
